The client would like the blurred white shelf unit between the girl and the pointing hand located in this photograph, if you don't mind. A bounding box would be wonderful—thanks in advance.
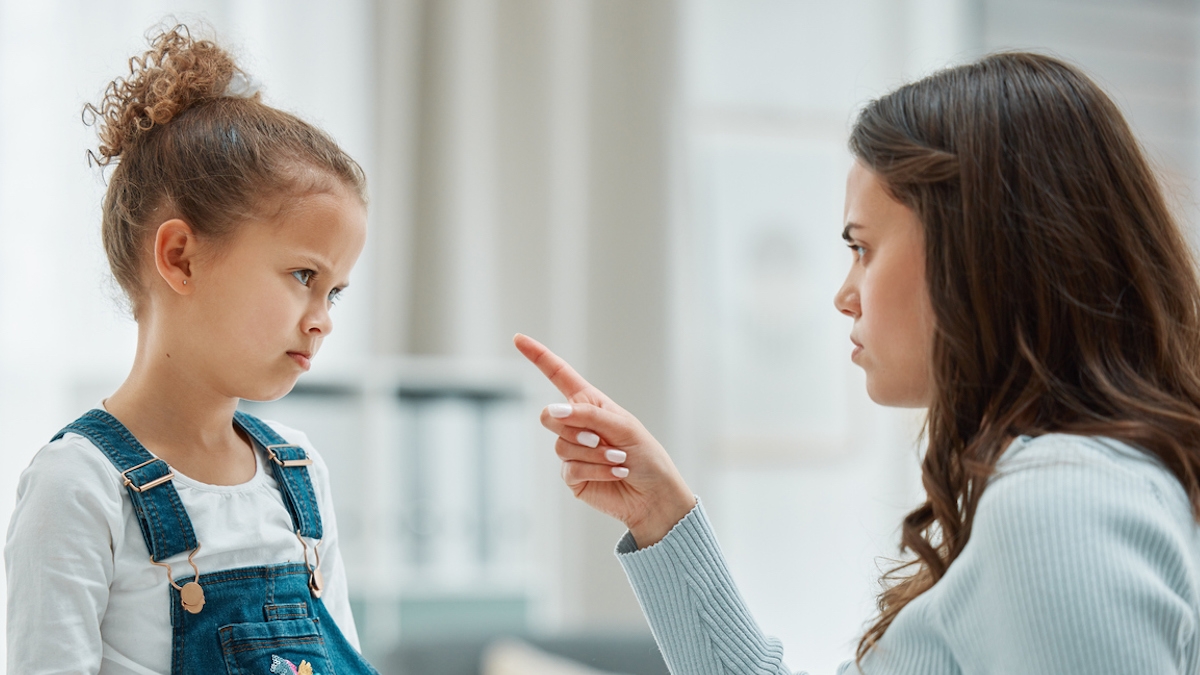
[242,358,550,659]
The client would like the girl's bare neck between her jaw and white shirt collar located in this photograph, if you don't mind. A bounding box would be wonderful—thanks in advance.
[104,330,257,485]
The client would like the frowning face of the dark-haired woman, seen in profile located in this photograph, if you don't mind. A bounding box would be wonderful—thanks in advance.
[834,161,934,407]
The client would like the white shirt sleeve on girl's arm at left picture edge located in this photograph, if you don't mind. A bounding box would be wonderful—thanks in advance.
[5,435,121,674]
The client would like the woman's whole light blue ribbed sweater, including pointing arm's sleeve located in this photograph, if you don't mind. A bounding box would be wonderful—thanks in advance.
[617,435,1200,675]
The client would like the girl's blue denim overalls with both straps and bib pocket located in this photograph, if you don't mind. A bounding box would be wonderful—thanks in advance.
[54,410,378,675]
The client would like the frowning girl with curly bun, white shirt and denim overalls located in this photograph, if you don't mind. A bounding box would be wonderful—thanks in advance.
[5,26,374,675]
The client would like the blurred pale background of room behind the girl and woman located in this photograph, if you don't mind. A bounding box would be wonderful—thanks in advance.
[0,0,1200,673]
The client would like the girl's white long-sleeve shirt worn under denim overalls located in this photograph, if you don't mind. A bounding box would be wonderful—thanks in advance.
[5,413,359,675]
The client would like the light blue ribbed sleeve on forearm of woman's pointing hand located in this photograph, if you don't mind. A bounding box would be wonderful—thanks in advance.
[617,503,803,675]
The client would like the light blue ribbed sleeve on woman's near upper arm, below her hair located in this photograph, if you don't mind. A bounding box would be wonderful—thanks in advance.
[936,436,1196,675]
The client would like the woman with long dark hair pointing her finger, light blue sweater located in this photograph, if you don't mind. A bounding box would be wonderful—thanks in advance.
[516,53,1200,675]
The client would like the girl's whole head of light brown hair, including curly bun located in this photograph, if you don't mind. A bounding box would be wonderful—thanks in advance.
[83,25,366,318]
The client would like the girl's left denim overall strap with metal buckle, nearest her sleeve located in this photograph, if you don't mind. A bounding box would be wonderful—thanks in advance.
[52,410,197,562]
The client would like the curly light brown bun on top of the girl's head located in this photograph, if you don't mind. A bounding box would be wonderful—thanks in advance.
[84,24,243,166]
